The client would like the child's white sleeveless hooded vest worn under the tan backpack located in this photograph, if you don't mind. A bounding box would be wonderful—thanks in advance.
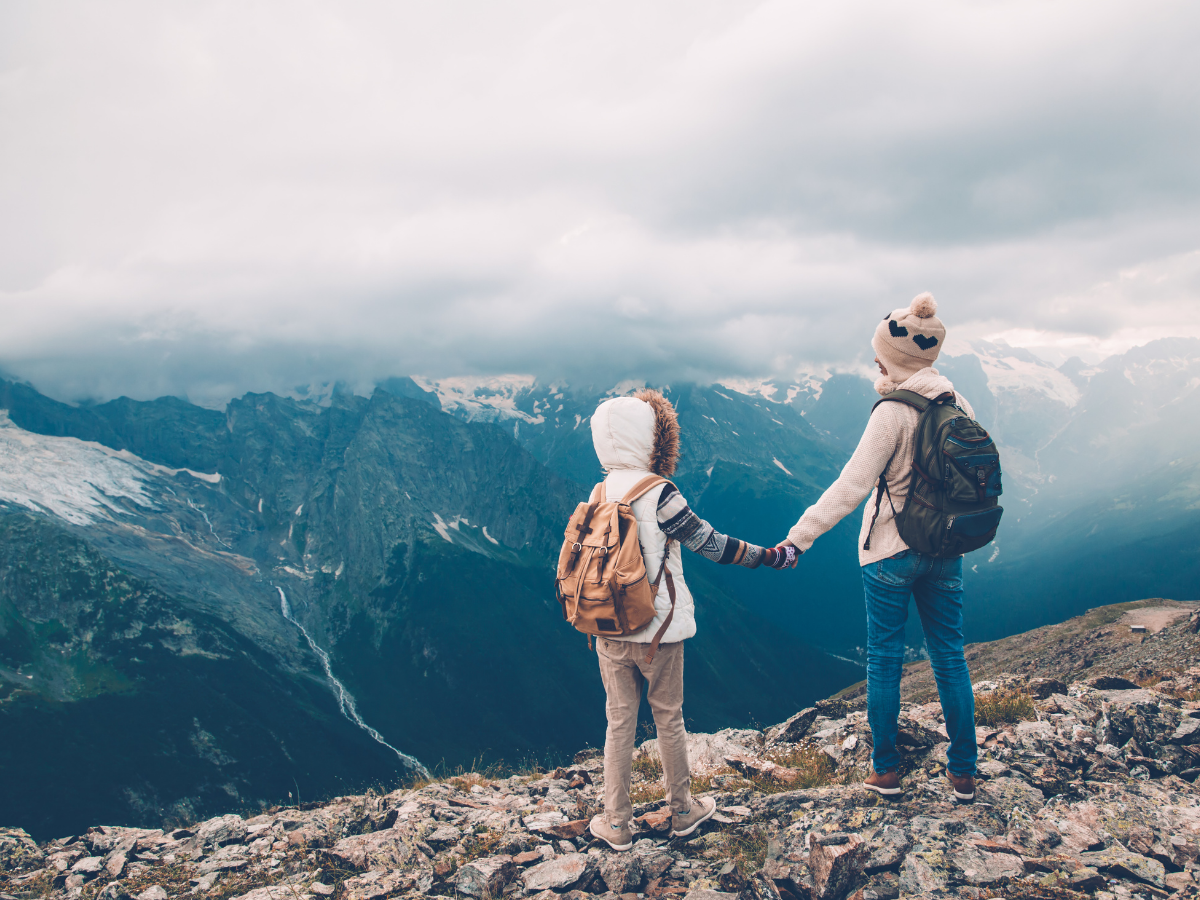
[592,397,696,643]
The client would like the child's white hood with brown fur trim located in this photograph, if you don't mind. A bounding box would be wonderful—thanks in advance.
[592,389,679,478]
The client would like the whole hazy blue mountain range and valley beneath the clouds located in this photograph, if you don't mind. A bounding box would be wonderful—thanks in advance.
[0,338,1200,834]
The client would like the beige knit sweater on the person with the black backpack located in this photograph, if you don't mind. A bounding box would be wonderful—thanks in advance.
[787,367,974,565]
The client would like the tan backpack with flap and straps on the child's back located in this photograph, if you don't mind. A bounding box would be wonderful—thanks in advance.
[556,475,676,662]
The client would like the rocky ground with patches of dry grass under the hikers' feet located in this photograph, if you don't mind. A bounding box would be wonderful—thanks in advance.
[7,607,1200,900]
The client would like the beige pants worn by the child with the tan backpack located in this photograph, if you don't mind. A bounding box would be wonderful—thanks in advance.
[596,637,691,826]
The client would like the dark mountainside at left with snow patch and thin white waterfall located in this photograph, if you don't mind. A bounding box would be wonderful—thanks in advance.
[0,379,860,838]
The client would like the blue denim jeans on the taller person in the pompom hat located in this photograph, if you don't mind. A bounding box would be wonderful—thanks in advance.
[863,550,978,775]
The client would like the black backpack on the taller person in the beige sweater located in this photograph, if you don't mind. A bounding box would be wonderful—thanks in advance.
[863,391,1004,559]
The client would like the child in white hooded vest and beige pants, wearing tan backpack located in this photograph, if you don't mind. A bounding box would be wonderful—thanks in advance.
[589,390,794,850]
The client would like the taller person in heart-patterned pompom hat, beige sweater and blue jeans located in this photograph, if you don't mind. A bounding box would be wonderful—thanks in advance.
[780,293,977,802]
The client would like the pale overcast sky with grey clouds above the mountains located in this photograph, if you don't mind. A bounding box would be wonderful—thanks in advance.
[0,0,1200,402]
